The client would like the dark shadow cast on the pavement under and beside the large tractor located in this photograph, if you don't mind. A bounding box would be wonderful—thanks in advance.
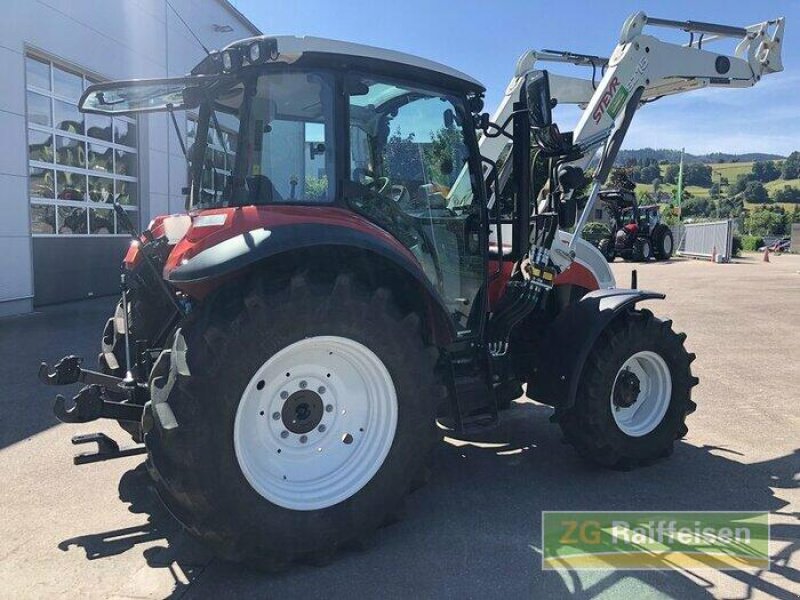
[53,403,800,600]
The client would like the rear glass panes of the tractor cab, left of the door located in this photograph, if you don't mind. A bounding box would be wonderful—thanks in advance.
[188,71,335,208]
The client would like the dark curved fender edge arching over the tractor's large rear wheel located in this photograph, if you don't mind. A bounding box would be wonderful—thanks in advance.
[165,223,456,343]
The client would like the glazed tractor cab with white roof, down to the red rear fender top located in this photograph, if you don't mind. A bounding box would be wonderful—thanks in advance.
[81,36,488,335]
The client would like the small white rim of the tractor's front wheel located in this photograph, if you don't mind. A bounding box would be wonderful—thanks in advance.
[610,350,672,437]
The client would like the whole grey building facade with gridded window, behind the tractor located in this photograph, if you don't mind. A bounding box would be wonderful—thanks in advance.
[0,0,260,316]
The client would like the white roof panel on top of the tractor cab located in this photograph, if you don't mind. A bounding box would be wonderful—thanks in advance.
[216,35,486,93]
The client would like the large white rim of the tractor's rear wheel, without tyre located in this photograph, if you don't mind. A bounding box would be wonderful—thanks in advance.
[238,336,397,510]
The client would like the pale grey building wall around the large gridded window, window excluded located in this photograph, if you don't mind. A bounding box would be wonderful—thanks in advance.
[0,0,256,316]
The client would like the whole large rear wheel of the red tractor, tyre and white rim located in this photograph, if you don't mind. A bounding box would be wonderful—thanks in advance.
[145,275,442,569]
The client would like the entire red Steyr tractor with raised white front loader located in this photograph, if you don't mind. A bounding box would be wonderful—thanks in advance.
[40,13,783,568]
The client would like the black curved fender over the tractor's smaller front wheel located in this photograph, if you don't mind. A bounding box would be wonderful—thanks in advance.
[526,289,666,408]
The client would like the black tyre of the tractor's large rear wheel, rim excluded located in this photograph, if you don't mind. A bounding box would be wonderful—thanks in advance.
[145,275,445,570]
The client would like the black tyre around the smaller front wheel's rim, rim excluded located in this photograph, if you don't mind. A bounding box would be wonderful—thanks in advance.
[559,310,698,469]
